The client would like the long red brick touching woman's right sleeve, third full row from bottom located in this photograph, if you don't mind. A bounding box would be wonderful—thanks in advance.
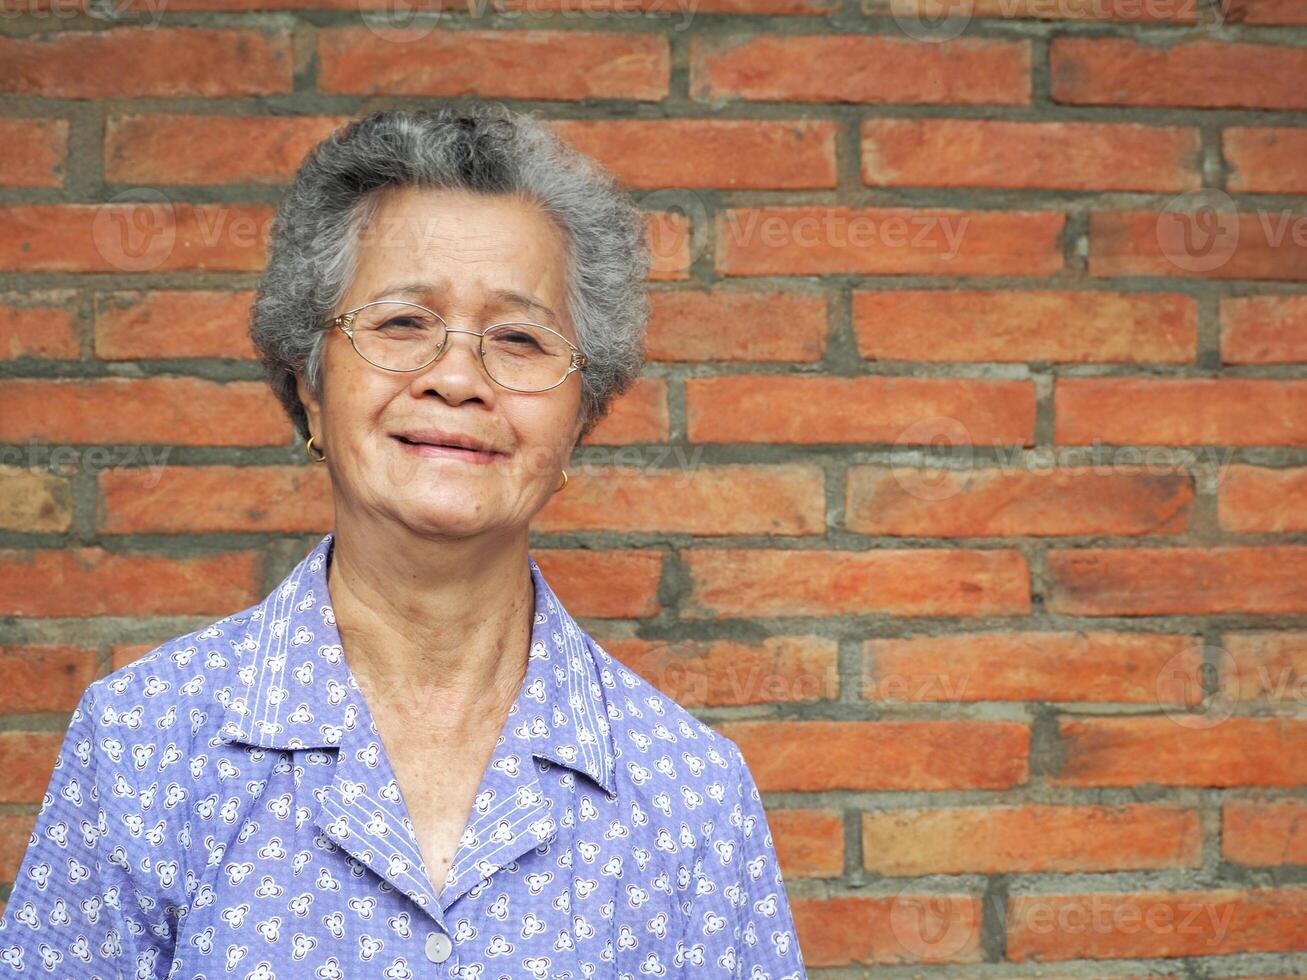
[714,721,1030,793]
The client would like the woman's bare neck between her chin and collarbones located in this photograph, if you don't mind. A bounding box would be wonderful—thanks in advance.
[327,514,535,736]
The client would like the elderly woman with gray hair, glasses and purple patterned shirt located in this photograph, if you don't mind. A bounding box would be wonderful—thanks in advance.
[0,103,805,980]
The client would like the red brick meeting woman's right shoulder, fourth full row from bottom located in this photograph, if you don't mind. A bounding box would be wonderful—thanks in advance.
[604,636,839,707]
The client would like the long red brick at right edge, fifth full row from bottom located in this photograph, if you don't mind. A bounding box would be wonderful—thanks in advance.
[1047,545,1307,615]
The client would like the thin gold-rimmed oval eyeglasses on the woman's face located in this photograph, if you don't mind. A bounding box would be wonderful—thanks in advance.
[332,299,586,391]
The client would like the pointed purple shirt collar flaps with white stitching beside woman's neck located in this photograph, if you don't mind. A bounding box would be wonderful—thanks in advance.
[217,533,616,794]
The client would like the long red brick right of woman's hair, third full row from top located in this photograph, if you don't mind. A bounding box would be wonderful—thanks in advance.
[715,205,1067,276]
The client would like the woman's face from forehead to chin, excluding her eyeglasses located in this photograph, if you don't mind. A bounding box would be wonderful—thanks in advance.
[299,188,582,546]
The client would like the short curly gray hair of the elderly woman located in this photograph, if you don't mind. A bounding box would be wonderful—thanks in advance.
[250,99,650,438]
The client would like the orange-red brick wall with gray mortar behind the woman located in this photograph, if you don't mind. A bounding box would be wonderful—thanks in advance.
[0,0,1307,977]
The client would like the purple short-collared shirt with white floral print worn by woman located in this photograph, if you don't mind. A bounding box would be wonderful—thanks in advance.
[0,534,806,980]
